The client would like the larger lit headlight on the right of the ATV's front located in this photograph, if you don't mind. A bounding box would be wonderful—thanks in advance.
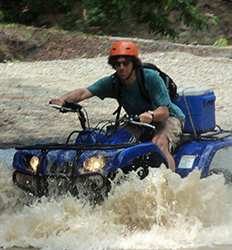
[83,155,106,172]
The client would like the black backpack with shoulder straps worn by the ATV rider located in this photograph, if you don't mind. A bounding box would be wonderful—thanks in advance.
[114,63,178,104]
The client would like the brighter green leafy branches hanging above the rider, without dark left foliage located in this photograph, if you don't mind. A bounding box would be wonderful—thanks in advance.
[82,0,208,37]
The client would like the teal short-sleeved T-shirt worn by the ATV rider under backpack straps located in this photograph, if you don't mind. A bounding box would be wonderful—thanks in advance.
[88,69,184,120]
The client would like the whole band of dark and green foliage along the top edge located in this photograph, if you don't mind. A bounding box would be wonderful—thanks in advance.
[0,0,208,37]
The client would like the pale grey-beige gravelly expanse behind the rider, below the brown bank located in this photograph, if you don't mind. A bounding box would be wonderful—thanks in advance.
[0,46,232,147]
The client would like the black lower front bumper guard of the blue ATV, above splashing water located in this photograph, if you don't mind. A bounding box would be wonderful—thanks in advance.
[13,171,111,203]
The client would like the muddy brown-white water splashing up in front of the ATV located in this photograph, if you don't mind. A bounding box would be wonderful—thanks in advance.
[0,151,232,250]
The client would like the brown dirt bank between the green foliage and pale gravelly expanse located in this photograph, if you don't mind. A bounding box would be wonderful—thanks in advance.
[0,25,232,62]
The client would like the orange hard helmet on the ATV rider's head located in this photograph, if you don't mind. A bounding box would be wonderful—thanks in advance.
[109,40,139,57]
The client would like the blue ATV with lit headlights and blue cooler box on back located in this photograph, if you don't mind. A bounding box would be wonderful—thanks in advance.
[13,91,232,202]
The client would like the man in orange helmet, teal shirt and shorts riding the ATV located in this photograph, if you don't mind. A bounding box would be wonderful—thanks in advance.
[49,40,185,171]
